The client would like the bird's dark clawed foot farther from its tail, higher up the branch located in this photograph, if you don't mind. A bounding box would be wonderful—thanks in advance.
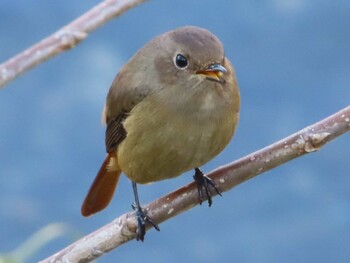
[193,167,221,206]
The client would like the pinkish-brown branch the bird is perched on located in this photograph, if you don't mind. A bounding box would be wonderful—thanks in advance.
[41,106,350,263]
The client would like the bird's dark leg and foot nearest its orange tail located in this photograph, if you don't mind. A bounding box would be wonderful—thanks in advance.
[131,182,159,241]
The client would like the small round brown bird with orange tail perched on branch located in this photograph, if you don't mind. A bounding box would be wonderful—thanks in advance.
[81,26,240,240]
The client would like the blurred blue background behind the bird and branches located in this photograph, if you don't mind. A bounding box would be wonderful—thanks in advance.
[0,0,350,263]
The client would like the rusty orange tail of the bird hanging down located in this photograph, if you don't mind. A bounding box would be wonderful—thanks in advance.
[81,153,121,216]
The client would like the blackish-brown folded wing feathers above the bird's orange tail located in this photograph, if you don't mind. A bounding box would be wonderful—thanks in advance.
[106,111,127,153]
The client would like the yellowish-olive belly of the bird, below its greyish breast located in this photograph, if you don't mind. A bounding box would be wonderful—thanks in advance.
[117,100,234,183]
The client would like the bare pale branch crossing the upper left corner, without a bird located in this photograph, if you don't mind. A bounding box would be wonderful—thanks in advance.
[0,0,145,88]
